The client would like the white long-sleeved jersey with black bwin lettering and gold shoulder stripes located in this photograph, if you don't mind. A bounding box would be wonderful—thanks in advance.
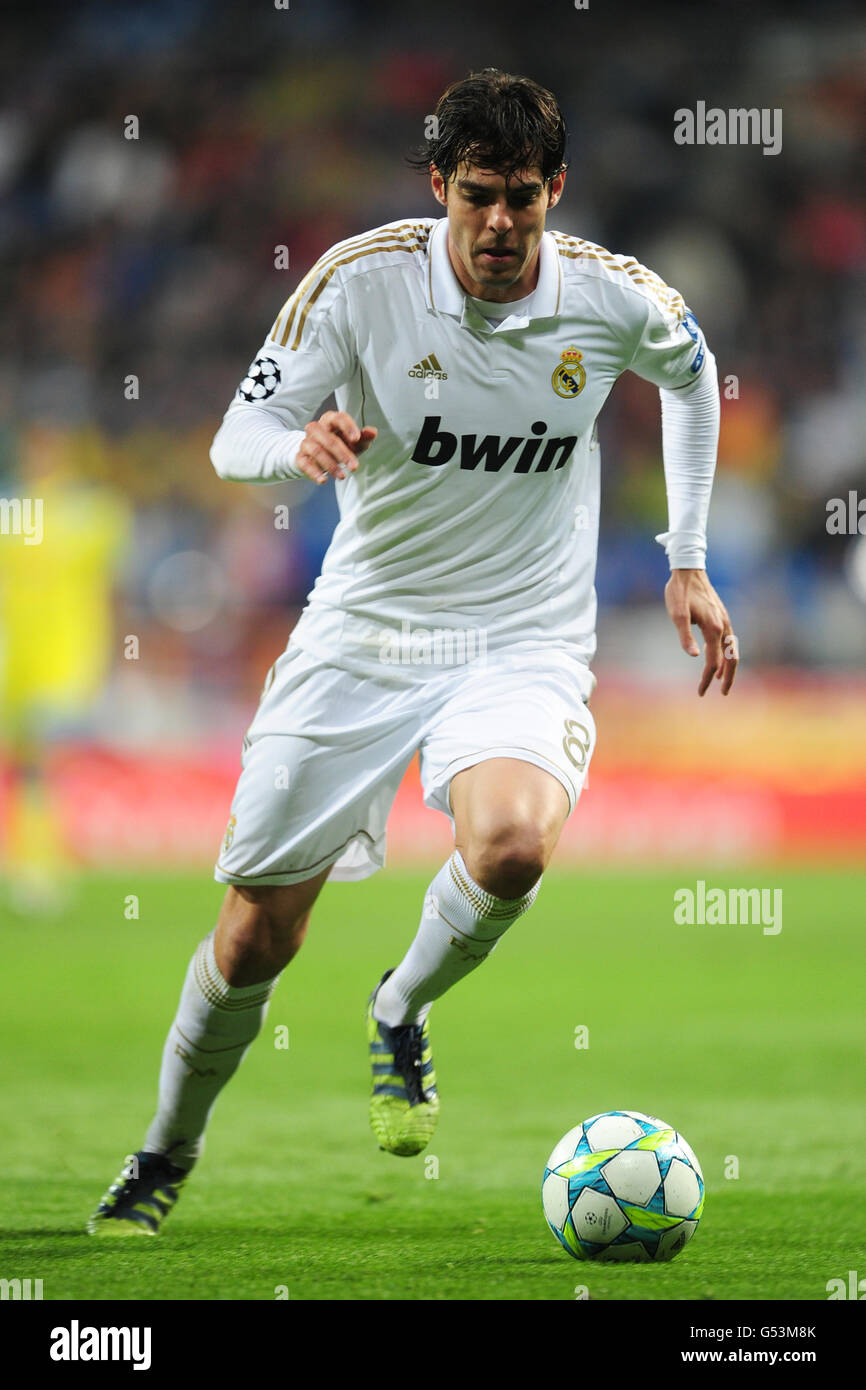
[211,218,719,674]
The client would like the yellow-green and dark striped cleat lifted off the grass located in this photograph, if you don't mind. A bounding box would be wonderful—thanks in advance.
[367,970,439,1158]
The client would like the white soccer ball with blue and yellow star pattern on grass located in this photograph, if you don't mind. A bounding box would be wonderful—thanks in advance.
[541,1111,703,1264]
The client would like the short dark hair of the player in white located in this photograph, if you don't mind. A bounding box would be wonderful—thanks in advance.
[409,68,566,183]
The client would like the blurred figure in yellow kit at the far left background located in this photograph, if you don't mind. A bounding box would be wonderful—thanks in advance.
[0,427,129,912]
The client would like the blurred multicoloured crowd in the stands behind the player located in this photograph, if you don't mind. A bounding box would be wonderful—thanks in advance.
[0,0,866,884]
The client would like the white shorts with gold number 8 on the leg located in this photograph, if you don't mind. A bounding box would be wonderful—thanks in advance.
[214,644,595,887]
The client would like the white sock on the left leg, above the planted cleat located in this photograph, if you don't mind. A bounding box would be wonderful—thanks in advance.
[142,931,279,1168]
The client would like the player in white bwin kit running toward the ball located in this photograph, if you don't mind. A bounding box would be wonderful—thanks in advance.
[89,68,737,1234]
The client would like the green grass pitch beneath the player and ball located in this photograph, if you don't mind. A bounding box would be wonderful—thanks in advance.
[0,867,866,1300]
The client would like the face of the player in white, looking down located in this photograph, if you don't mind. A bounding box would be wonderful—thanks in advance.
[431,164,566,303]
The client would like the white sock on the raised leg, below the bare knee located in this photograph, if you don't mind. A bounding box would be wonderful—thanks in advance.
[374,849,541,1027]
